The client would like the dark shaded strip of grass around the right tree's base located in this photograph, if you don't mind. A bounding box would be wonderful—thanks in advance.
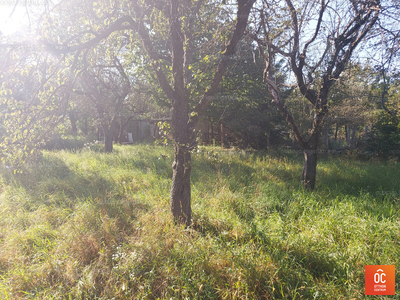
[247,151,400,198]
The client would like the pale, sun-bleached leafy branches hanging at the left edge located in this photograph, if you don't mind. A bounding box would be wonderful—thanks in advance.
[0,39,72,166]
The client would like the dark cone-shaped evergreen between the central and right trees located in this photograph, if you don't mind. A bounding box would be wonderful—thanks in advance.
[202,37,289,149]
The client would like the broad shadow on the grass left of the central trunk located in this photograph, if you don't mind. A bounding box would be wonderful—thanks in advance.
[0,155,151,243]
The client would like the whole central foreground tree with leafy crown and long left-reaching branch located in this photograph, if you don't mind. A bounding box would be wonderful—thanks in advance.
[38,0,255,225]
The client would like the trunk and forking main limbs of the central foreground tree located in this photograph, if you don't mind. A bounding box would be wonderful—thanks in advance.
[133,0,254,225]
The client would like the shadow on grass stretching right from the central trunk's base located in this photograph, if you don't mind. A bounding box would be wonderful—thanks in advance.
[193,214,347,299]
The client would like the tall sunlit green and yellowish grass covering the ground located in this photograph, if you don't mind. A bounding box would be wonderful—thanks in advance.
[0,145,400,299]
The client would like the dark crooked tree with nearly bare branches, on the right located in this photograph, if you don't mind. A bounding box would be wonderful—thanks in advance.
[251,0,381,189]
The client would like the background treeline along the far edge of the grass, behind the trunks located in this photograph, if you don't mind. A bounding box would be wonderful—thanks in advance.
[1,40,400,157]
